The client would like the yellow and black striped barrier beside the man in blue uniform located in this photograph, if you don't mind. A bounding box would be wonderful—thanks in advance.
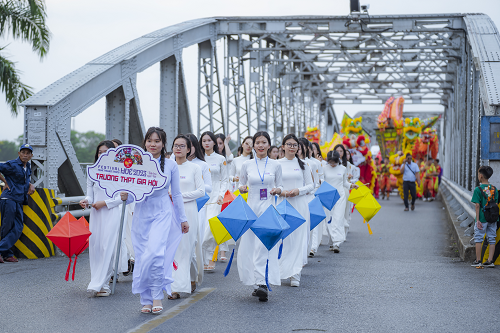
[0,188,55,259]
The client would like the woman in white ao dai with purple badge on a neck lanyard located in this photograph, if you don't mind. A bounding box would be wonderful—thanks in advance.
[237,132,283,302]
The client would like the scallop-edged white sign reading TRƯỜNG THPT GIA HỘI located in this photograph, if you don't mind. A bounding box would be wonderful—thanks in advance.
[87,145,168,201]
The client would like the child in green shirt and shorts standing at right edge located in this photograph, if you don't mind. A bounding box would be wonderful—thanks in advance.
[471,166,498,267]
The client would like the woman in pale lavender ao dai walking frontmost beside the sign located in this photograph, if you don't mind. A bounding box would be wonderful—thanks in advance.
[132,127,189,314]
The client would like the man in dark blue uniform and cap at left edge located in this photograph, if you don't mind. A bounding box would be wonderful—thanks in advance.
[0,144,35,263]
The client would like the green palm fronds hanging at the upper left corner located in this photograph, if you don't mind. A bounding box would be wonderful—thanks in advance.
[0,0,50,116]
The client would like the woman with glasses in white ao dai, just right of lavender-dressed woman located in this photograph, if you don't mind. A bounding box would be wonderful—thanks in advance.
[168,134,205,299]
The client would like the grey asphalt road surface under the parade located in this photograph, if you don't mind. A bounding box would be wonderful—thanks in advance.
[0,196,500,333]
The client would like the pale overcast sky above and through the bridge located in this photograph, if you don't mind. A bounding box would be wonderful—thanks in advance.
[0,0,500,140]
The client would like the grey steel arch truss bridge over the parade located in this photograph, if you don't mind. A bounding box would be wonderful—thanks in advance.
[23,13,500,196]
